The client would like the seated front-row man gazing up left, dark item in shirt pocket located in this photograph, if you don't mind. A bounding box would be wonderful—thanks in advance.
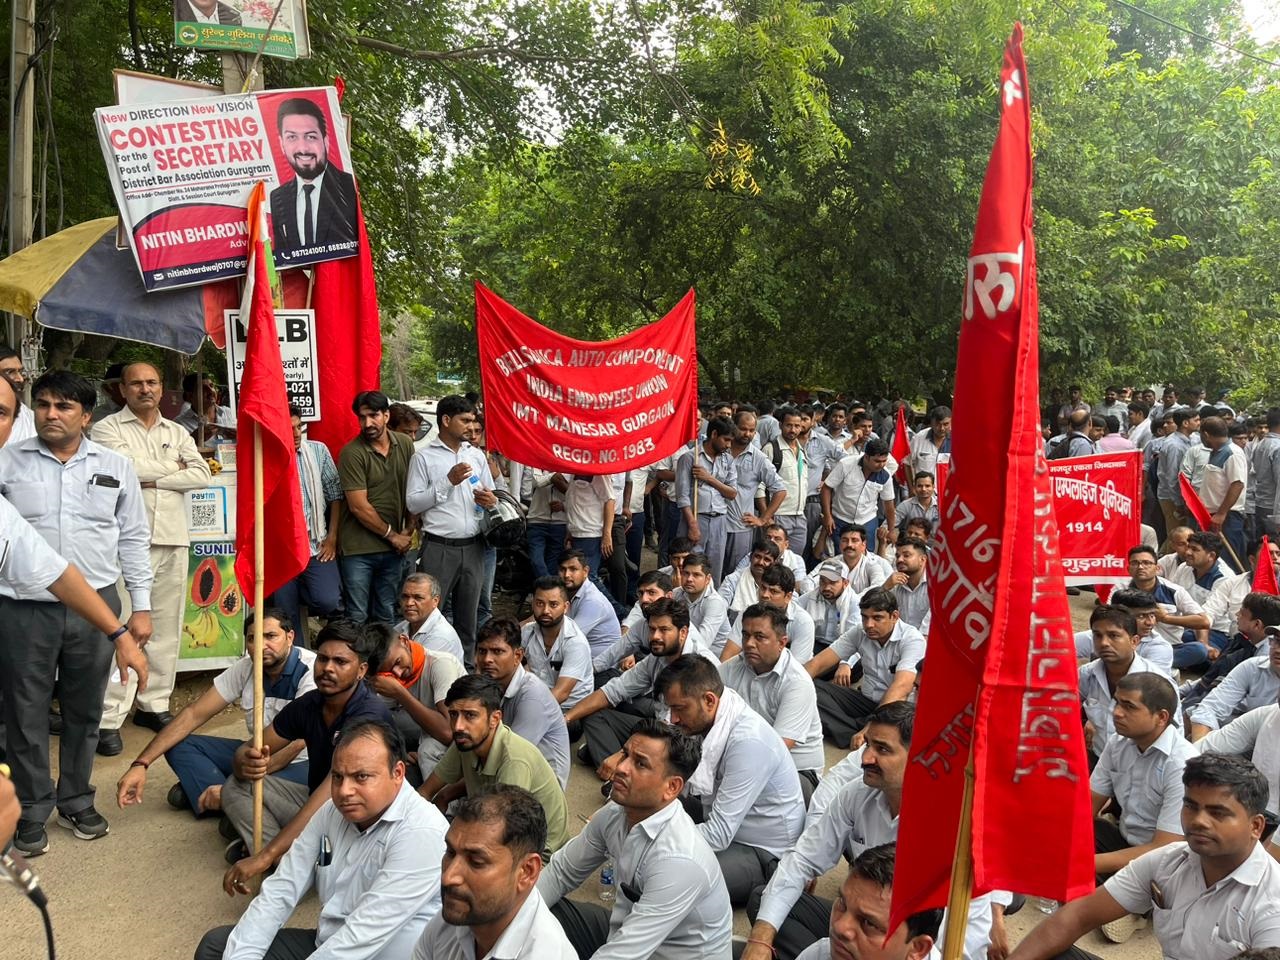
[538,719,733,960]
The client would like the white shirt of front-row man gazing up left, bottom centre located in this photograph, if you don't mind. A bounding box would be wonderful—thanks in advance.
[535,800,733,960]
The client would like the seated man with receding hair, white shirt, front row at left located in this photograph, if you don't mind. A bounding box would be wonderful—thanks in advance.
[196,719,448,960]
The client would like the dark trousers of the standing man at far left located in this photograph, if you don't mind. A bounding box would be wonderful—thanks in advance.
[0,584,120,823]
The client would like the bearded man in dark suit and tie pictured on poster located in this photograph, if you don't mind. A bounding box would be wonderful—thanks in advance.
[271,97,356,262]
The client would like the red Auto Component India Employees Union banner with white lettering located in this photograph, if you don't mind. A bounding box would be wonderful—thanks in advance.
[476,283,698,475]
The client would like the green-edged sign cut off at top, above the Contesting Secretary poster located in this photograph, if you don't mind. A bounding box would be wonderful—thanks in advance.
[173,0,311,60]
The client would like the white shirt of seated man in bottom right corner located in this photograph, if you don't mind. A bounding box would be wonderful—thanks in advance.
[1103,842,1280,960]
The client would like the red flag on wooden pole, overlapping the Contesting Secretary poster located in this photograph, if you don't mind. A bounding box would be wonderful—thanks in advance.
[236,183,309,598]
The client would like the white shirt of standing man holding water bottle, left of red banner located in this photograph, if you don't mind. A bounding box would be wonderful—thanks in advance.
[404,436,493,540]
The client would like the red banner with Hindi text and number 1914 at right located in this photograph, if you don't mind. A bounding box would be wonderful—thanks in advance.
[1048,451,1142,585]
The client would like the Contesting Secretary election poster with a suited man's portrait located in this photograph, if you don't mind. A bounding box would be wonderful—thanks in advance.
[95,87,358,291]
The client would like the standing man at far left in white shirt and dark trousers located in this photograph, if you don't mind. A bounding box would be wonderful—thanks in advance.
[0,370,152,852]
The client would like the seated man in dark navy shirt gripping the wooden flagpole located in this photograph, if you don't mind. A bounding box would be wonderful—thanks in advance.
[223,620,392,892]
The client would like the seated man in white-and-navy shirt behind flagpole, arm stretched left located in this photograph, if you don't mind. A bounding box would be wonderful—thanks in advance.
[115,607,316,817]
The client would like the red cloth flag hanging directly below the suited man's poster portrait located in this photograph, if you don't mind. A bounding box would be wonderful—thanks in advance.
[307,195,383,460]
